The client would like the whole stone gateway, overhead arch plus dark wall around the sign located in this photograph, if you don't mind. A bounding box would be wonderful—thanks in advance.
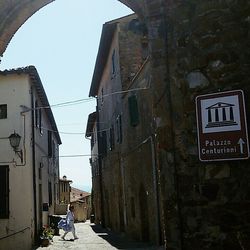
[0,0,250,250]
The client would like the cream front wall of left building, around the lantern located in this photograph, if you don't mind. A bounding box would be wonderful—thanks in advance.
[0,75,34,249]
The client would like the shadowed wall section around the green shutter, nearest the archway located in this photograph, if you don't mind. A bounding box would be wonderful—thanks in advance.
[121,61,160,244]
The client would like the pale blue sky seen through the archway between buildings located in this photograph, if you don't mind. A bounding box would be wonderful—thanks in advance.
[0,0,132,191]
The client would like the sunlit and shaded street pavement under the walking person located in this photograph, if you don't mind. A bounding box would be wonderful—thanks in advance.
[36,221,163,250]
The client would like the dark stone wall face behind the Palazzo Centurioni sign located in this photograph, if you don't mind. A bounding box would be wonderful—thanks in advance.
[167,1,250,249]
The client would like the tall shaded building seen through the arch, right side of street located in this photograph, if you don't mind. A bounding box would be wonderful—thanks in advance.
[87,15,159,242]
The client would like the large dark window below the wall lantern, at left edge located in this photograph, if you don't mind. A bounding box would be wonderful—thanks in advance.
[0,166,9,219]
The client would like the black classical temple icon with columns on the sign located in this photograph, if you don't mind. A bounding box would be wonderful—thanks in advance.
[206,102,238,128]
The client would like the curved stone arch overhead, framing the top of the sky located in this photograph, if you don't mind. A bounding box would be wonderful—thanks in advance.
[0,0,142,56]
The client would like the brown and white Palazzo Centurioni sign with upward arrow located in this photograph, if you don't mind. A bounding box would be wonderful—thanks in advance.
[196,90,249,161]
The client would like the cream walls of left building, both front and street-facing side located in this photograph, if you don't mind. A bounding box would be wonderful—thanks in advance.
[0,71,59,250]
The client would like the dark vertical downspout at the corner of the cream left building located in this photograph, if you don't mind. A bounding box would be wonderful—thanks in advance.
[31,87,38,242]
